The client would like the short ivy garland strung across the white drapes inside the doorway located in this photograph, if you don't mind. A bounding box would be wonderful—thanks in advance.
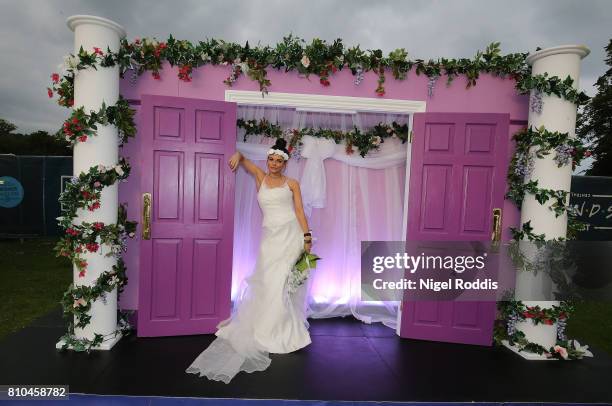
[236,118,408,157]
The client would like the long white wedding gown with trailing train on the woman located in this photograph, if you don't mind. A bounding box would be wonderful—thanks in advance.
[185,174,311,383]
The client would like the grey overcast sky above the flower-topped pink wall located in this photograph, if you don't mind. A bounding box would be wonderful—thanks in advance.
[0,0,612,137]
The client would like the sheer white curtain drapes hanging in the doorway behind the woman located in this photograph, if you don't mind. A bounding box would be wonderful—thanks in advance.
[232,106,408,328]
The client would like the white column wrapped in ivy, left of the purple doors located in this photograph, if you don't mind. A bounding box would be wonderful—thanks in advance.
[58,15,126,349]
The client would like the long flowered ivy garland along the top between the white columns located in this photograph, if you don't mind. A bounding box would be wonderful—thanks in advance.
[47,39,588,106]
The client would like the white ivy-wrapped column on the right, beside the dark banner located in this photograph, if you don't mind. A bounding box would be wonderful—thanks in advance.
[517,45,590,356]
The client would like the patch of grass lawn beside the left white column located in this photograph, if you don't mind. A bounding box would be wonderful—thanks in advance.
[0,238,72,338]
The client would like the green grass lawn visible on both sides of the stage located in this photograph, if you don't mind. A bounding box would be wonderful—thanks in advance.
[0,238,612,354]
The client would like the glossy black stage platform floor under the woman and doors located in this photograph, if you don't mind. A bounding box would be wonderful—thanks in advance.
[0,308,612,403]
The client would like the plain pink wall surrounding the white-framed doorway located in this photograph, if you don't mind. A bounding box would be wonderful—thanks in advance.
[119,63,529,309]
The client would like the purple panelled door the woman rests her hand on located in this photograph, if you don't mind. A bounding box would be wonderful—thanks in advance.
[138,95,236,337]
